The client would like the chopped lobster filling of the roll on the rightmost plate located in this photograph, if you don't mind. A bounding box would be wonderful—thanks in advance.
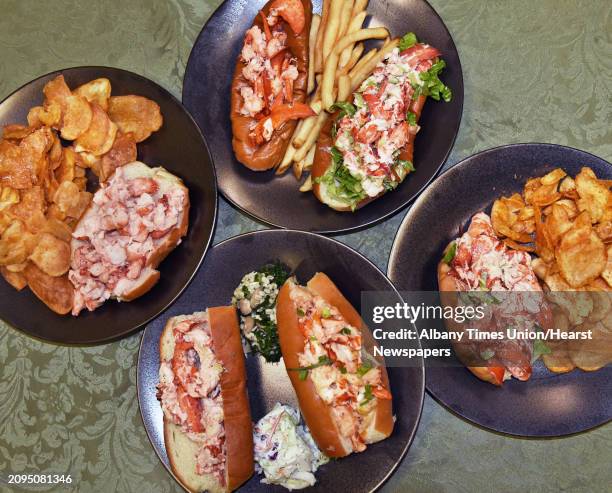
[443,212,552,384]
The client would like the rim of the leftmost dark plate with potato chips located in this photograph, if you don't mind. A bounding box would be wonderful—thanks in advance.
[0,65,219,347]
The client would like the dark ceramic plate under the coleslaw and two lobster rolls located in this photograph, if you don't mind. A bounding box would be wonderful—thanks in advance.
[138,230,424,493]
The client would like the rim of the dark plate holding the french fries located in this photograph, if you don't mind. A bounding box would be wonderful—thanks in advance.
[181,0,465,236]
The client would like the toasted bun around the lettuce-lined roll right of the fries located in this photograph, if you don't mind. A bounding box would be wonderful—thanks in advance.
[311,95,427,212]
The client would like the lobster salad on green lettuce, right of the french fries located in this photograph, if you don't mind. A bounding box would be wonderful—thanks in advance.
[320,33,451,207]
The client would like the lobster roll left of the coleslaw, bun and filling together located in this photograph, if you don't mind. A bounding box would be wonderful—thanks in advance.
[157,306,254,493]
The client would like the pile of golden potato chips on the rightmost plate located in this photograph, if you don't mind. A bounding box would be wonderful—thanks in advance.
[491,167,612,373]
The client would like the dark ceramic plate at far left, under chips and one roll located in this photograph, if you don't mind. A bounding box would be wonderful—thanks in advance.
[0,67,217,344]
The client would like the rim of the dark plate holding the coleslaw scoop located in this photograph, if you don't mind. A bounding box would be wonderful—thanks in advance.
[136,228,427,493]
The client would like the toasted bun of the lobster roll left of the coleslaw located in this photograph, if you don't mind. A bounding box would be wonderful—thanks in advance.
[159,306,254,493]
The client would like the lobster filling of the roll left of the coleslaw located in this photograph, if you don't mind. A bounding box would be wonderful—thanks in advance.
[157,313,226,485]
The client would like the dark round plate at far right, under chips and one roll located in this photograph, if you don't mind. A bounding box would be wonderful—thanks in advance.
[388,144,612,437]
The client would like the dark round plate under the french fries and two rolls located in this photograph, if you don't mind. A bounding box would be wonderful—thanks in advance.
[183,0,463,233]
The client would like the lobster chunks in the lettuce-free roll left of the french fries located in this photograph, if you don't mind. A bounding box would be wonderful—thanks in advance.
[239,0,314,144]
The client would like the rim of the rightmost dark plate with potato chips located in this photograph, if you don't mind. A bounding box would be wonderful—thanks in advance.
[386,141,612,439]
